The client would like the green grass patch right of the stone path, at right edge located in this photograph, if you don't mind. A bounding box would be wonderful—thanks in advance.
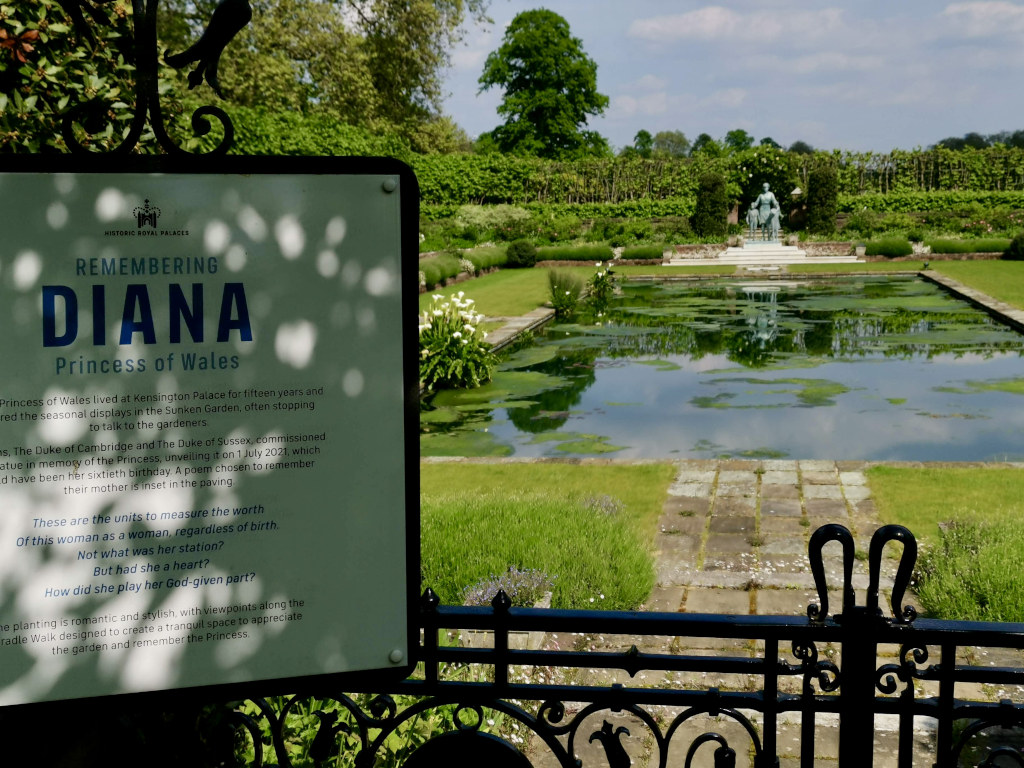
[867,467,1024,622]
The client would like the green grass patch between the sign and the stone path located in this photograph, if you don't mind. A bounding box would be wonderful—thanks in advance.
[420,463,675,609]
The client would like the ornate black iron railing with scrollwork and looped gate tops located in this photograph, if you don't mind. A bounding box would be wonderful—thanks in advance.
[226,525,1024,768]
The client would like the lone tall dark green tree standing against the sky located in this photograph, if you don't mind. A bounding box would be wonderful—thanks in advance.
[479,9,608,158]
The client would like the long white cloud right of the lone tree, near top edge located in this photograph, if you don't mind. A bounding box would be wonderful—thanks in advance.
[627,5,844,44]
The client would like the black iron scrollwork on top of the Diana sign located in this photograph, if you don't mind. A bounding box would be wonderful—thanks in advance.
[60,0,252,156]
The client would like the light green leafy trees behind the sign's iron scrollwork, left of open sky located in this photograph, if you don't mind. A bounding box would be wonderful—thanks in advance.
[160,0,488,150]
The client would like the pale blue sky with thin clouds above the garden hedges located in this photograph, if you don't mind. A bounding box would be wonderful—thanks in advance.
[444,0,1024,152]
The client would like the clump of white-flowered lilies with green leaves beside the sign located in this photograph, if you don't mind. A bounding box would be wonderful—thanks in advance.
[420,291,495,390]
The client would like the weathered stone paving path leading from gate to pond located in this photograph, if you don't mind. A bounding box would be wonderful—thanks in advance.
[530,461,1024,768]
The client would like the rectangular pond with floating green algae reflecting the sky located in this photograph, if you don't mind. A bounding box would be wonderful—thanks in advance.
[421,276,1024,461]
